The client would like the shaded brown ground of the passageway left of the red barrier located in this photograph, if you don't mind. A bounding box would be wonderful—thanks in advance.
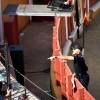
[20,21,54,100]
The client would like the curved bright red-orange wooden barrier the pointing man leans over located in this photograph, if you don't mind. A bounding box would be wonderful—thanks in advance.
[52,17,95,100]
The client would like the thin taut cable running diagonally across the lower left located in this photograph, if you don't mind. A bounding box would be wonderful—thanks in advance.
[0,55,58,100]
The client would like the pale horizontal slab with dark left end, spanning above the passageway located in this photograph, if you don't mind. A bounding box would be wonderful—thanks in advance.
[3,4,72,17]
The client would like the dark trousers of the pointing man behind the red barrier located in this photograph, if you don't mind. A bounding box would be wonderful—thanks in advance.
[76,73,90,90]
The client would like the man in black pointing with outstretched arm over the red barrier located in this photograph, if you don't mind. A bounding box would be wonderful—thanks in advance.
[48,45,89,89]
